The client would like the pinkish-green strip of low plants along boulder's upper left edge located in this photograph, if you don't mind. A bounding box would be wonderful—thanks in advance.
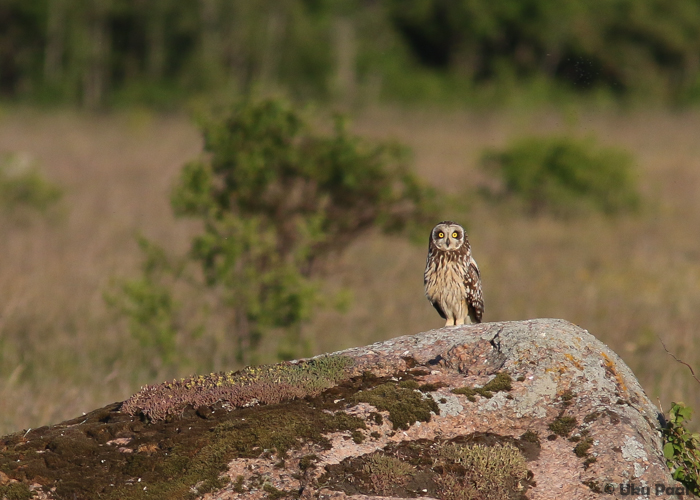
[121,356,354,421]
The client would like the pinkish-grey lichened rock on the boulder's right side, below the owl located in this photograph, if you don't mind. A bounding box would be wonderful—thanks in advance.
[202,320,677,499]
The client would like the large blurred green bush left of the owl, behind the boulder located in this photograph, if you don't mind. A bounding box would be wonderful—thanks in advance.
[112,100,434,368]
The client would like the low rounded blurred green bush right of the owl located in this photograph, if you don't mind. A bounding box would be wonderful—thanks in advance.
[482,136,639,215]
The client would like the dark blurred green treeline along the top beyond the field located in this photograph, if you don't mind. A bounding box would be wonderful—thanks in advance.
[0,0,700,109]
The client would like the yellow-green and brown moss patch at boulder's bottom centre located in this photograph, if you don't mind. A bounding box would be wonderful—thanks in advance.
[319,433,539,500]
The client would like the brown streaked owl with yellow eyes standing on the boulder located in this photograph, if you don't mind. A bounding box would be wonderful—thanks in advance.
[423,221,484,326]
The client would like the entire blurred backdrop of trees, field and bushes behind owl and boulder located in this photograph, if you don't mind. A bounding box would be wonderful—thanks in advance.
[0,0,700,433]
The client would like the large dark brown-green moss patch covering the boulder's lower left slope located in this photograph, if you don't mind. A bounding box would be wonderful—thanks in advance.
[0,368,382,500]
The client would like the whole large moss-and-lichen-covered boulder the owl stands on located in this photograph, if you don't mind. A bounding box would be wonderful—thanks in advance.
[0,319,680,500]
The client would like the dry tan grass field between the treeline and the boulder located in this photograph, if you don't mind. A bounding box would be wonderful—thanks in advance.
[0,109,700,435]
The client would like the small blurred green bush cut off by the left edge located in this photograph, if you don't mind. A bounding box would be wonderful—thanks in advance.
[0,154,62,212]
